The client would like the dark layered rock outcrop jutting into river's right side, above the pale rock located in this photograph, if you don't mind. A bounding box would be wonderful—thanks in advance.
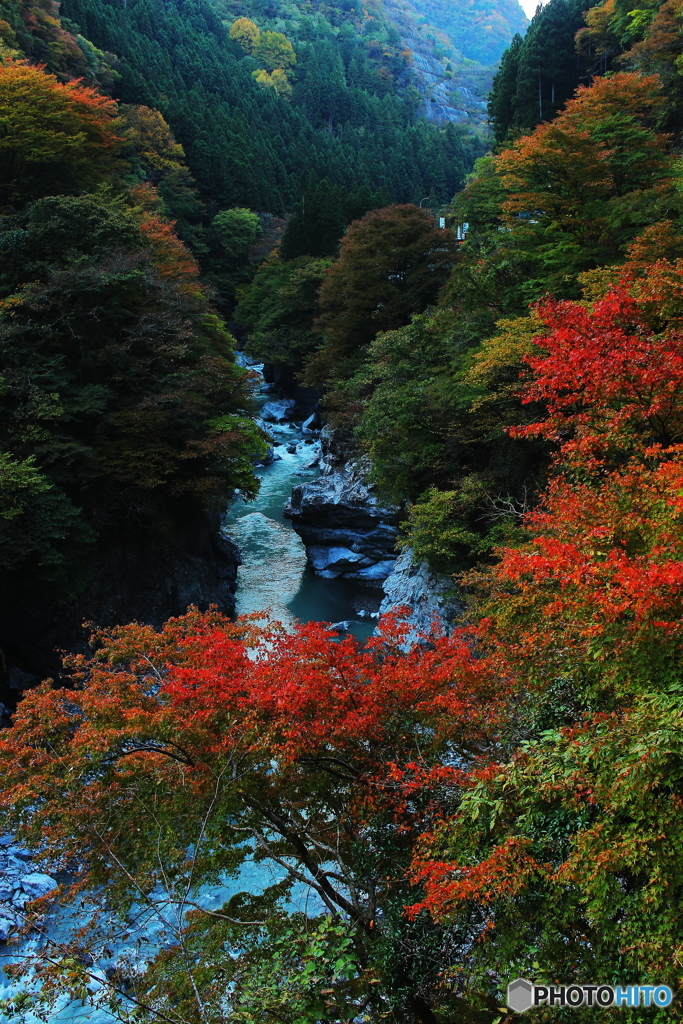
[284,427,398,586]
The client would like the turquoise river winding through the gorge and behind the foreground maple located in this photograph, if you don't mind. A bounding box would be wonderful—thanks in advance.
[0,397,381,1024]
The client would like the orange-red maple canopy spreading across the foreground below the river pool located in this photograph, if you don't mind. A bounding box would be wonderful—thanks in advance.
[0,612,508,892]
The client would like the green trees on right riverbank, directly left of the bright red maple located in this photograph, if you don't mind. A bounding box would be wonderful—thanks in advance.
[348,309,546,571]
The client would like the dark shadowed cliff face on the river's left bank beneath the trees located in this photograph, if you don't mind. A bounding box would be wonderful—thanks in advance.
[0,516,241,692]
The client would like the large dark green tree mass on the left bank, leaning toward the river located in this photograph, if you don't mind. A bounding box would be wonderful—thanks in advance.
[0,196,262,589]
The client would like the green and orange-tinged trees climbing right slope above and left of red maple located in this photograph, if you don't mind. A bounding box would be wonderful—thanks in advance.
[331,74,680,571]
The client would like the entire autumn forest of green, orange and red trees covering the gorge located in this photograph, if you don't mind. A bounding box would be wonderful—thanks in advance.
[0,0,683,1024]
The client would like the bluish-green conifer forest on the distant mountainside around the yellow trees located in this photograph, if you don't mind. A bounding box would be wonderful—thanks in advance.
[61,0,480,216]
